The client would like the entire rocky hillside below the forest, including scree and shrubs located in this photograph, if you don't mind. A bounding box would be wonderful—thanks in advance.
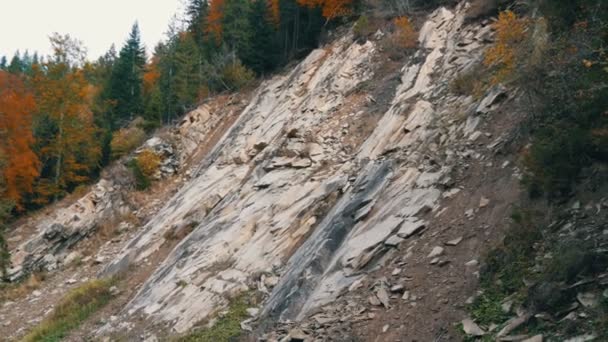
[0,1,608,342]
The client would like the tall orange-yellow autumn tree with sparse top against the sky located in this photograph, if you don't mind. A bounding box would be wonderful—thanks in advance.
[33,35,101,203]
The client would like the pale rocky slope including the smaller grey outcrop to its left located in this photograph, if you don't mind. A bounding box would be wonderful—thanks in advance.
[0,3,536,340]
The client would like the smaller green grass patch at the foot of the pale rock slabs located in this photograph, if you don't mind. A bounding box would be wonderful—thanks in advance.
[175,293,250,342]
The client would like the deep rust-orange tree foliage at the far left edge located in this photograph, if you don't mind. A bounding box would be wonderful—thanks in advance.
[0,70,40,210]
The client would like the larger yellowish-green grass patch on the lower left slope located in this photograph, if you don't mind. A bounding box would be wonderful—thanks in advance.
[21,279,115,342]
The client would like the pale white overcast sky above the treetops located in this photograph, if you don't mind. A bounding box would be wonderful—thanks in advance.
[0,0,184,61]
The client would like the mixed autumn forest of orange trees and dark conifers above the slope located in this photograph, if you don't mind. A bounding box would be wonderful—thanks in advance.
[0,0,366,216]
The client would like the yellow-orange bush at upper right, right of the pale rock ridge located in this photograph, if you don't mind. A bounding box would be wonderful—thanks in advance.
[484,11,528,83]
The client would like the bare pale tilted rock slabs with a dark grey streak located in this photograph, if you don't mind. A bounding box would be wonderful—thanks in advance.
[92,3,492,332]
